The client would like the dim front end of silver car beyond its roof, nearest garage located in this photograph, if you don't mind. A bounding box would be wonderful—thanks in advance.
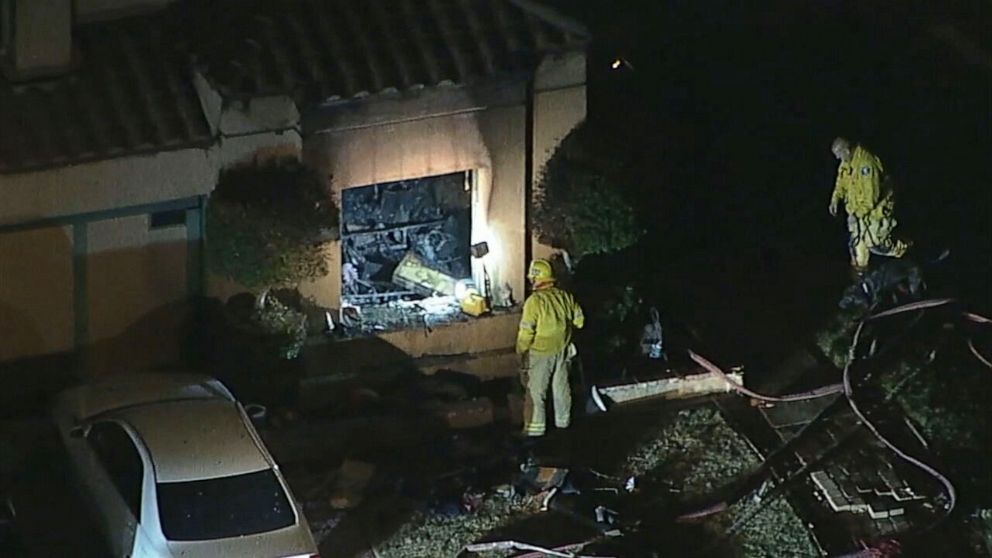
[62,373,234,420]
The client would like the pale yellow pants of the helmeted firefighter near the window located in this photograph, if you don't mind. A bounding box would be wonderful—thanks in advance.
[520,343,576,436]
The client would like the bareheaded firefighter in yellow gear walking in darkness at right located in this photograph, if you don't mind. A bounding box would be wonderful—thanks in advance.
[830,138,910,273]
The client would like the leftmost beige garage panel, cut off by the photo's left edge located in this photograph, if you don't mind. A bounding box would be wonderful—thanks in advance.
[0,227,73,360]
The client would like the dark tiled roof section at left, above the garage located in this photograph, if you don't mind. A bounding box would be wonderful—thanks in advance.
[0,16,210,173]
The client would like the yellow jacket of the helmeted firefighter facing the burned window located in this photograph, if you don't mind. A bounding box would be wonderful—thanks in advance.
[517,284,585,355]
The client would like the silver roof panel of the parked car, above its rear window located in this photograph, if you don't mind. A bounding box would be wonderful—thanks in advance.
[113,399,272,482]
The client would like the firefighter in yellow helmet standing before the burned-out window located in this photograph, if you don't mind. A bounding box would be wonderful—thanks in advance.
[517,260,585,436]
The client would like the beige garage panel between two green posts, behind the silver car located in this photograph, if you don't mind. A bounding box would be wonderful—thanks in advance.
[86,215,186,374]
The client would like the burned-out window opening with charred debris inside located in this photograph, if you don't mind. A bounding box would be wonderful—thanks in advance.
[341,171,473,329]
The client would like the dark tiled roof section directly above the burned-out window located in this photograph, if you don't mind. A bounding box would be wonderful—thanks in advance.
[190,0,586,101]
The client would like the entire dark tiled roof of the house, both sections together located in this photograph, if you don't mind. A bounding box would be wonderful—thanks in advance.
[0,0,587,173]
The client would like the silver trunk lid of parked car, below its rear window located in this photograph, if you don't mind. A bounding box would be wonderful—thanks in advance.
[168,525,317,558]
